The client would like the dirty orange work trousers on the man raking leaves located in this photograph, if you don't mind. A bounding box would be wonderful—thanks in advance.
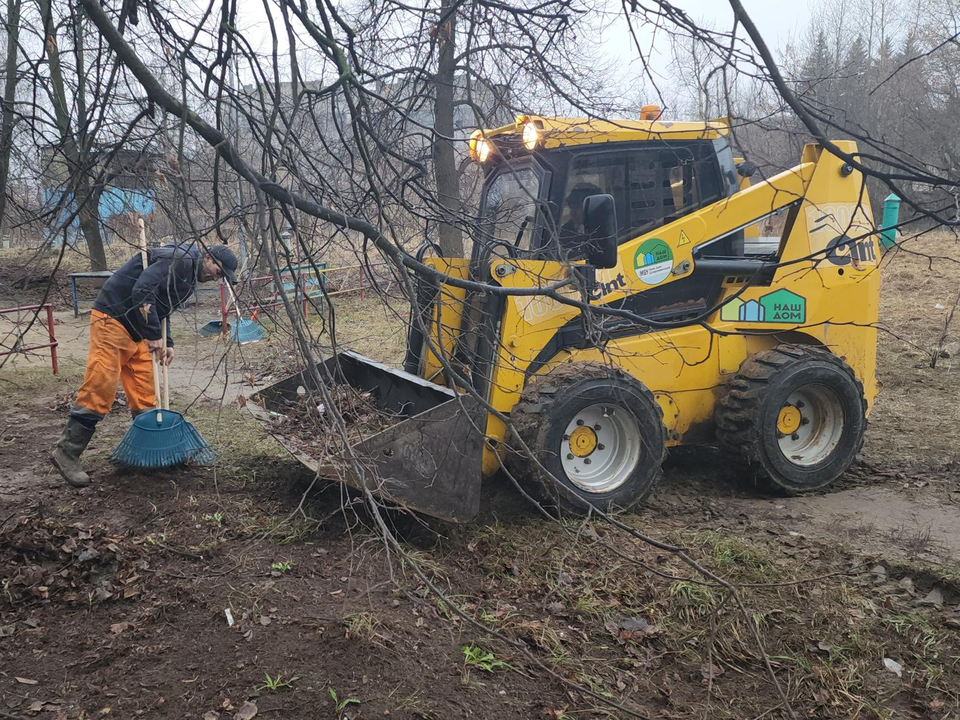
[77,310,157,417]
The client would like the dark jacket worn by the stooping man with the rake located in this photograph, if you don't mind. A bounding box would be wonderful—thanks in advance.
[93,245,203,347]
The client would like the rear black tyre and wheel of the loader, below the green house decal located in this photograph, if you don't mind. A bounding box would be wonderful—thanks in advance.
[715,345,867,493]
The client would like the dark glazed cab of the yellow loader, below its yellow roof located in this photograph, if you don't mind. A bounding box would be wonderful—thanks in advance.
[472,125,743,273]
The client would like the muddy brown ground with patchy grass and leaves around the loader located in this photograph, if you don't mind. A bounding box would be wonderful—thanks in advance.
[0,236,960,720]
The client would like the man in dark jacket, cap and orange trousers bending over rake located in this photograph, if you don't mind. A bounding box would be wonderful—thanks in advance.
[51,244,237,487]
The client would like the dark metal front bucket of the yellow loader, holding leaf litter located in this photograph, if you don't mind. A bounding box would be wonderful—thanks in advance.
[247,351,486,522]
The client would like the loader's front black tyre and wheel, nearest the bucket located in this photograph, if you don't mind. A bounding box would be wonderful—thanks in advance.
[508,363,666,514]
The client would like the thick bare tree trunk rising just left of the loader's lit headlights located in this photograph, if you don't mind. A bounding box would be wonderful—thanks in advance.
[433,0,463,257]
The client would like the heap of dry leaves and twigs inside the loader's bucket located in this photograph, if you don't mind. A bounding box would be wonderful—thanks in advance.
[262,385,403,465]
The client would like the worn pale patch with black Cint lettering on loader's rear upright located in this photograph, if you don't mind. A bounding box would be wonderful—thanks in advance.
[806,203,877,267]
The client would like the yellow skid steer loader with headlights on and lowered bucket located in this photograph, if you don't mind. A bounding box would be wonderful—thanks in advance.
[248,109,880,521]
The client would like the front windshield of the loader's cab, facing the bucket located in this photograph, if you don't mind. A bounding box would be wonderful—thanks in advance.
[480,165,541,254]
